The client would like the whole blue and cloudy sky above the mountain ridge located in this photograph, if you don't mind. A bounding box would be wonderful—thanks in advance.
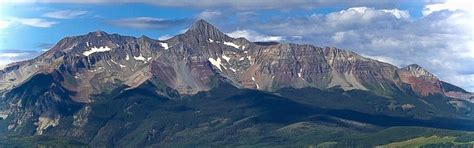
[0,0,474,91]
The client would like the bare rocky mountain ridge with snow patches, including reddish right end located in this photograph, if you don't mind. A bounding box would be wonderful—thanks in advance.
[0,20,474,142]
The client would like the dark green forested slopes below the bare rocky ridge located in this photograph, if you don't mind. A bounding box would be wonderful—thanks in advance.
[0,81,474,147]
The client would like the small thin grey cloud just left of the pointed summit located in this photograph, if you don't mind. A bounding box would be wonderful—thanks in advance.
[108,17,188,29]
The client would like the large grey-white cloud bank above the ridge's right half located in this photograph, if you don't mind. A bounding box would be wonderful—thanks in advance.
[248,5,474,91]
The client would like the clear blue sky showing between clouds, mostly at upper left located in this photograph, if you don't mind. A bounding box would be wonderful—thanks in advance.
[0,2,423,50]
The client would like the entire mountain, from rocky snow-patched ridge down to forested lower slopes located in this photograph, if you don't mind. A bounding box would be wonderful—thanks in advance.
[0,20,474,147]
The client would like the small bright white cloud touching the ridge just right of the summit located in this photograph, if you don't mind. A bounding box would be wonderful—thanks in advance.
[227,30,283,42]
